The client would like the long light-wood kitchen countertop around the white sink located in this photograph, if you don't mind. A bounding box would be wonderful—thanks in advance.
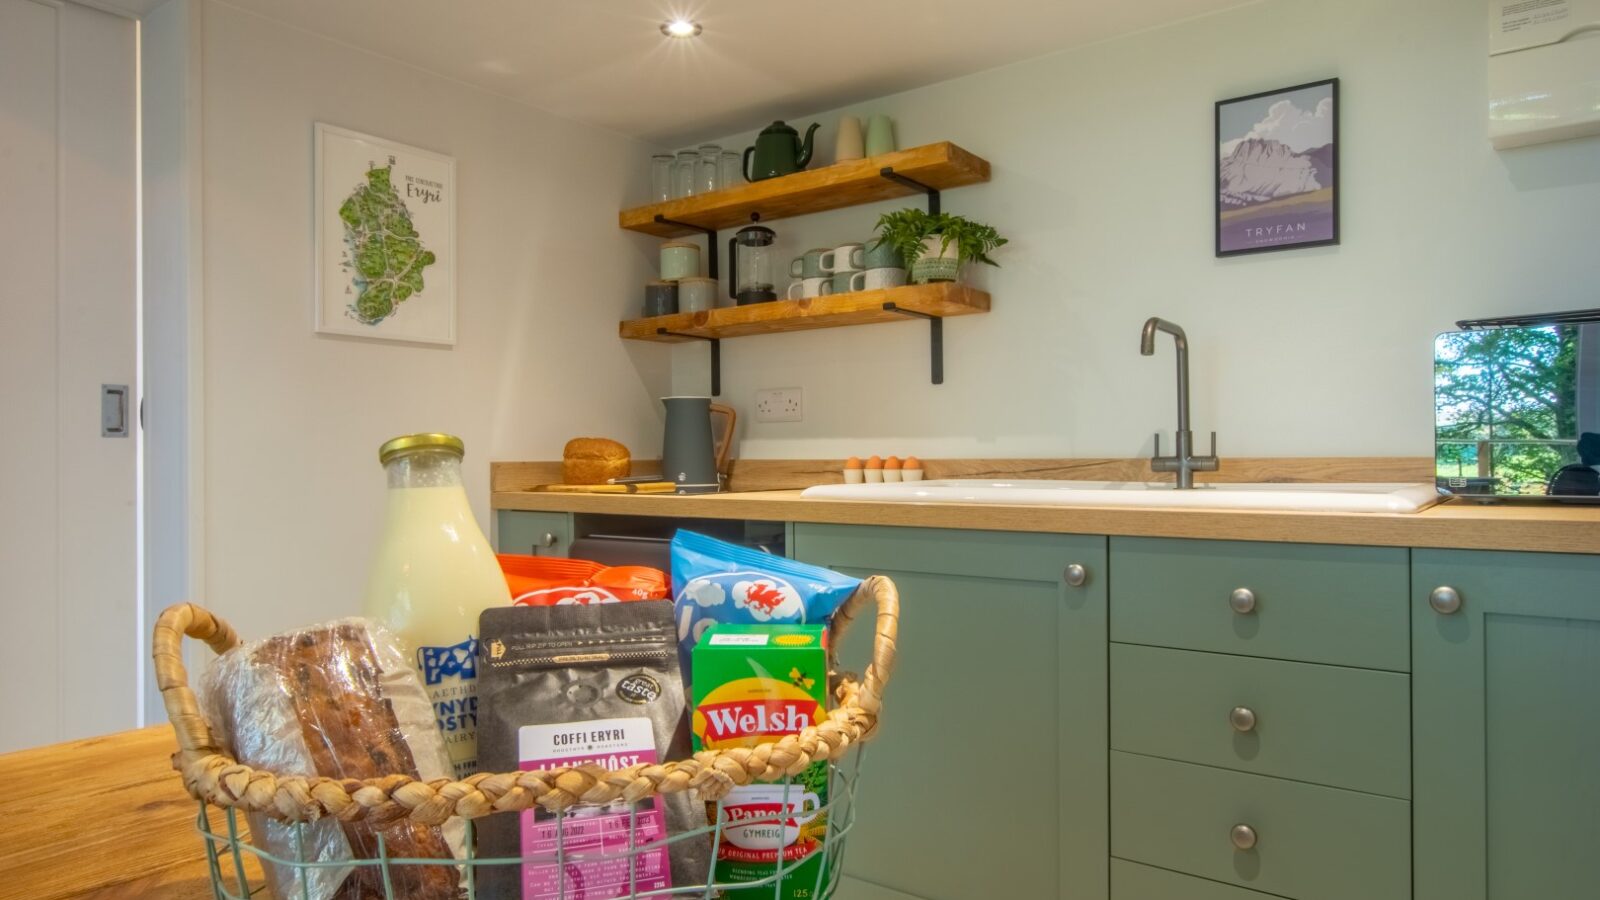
[491,490,1600,552]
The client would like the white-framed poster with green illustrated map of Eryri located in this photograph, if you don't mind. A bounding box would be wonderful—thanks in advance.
[314,122,456,344]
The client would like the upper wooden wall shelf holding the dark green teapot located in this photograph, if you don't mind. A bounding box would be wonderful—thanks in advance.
[618,141,989,237]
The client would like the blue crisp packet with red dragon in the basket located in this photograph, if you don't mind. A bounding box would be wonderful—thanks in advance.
[672,530,861,674]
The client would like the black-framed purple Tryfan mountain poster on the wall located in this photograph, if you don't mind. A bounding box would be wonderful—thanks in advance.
[1216,78,1339,256]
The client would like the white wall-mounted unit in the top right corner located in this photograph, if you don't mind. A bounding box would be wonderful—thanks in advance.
[1490,0,1600,151]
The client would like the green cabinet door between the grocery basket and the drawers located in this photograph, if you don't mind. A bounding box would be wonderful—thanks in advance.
[795,524,1110,900]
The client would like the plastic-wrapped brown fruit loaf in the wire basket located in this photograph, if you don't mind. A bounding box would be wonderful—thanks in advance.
[205,618,464,900]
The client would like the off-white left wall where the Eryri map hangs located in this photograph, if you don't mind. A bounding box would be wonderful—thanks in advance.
[203,2,669,636]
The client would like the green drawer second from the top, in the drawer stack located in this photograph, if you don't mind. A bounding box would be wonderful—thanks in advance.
[1110,644,1411,798]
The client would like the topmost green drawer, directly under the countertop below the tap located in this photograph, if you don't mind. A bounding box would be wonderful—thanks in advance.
[1110,538,1411,671]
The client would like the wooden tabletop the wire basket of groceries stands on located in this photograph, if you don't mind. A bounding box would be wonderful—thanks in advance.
[0,724,256,900]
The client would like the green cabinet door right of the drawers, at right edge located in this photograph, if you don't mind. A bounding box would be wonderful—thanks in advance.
[1411,549,1600,900]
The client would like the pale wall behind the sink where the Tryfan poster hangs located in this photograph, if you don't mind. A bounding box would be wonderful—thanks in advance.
[674,0,1600,460]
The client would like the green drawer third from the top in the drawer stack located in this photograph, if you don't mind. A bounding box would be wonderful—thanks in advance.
[1110,751,1411,900]
